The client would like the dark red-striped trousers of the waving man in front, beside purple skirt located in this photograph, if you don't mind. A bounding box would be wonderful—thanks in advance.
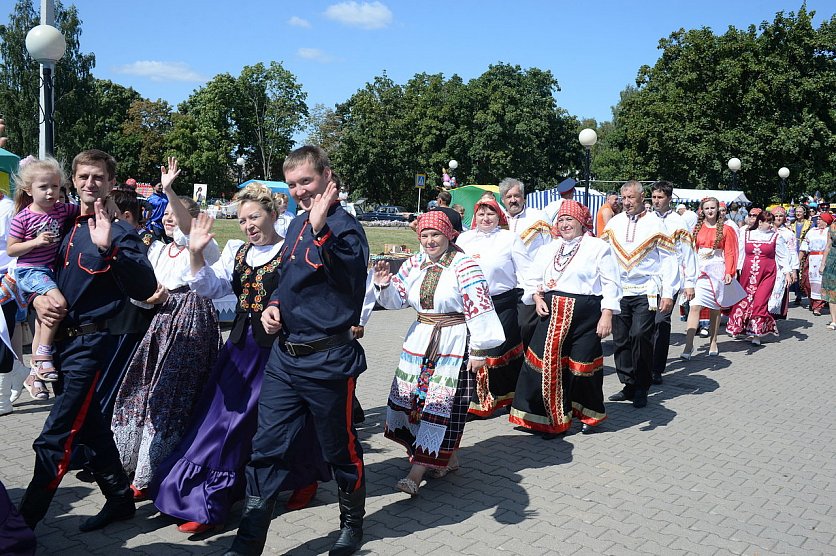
[240,346,366,500]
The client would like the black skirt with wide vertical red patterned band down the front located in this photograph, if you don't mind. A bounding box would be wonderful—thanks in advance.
[509,292,607,434]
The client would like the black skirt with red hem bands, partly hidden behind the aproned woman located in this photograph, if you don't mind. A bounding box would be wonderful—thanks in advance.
[468,289,523,417]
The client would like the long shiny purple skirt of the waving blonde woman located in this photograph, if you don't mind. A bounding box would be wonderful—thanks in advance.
[151,331,331,525]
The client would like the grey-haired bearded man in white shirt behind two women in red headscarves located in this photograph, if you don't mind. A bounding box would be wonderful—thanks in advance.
[499,178,552,348]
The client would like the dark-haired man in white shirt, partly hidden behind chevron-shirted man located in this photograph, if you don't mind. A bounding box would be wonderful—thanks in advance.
[650,181,699,384]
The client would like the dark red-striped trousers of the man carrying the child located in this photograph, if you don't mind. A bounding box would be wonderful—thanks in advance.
[21,332,124,521]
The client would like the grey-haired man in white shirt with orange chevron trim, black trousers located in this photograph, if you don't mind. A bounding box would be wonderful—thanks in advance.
[601,180,678,407]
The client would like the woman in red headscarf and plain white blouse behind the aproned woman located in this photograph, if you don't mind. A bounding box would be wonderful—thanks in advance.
[456,196,531,417]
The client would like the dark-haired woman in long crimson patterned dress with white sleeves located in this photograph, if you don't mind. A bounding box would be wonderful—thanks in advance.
[726,209,792,345]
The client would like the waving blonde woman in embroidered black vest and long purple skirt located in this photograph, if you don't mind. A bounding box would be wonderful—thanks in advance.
[152,182,330,534]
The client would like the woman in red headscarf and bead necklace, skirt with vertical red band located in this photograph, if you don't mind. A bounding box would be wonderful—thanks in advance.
[510,200,622,438]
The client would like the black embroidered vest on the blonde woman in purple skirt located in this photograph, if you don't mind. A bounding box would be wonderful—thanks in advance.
[229,243,281,348]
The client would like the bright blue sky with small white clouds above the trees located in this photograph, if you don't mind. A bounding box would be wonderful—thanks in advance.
[0,0,834,124]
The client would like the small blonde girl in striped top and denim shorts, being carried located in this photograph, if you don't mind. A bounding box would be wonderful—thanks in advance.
[7,157,79,399]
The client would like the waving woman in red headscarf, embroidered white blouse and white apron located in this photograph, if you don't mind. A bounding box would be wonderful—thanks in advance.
[373,211,505,496]
